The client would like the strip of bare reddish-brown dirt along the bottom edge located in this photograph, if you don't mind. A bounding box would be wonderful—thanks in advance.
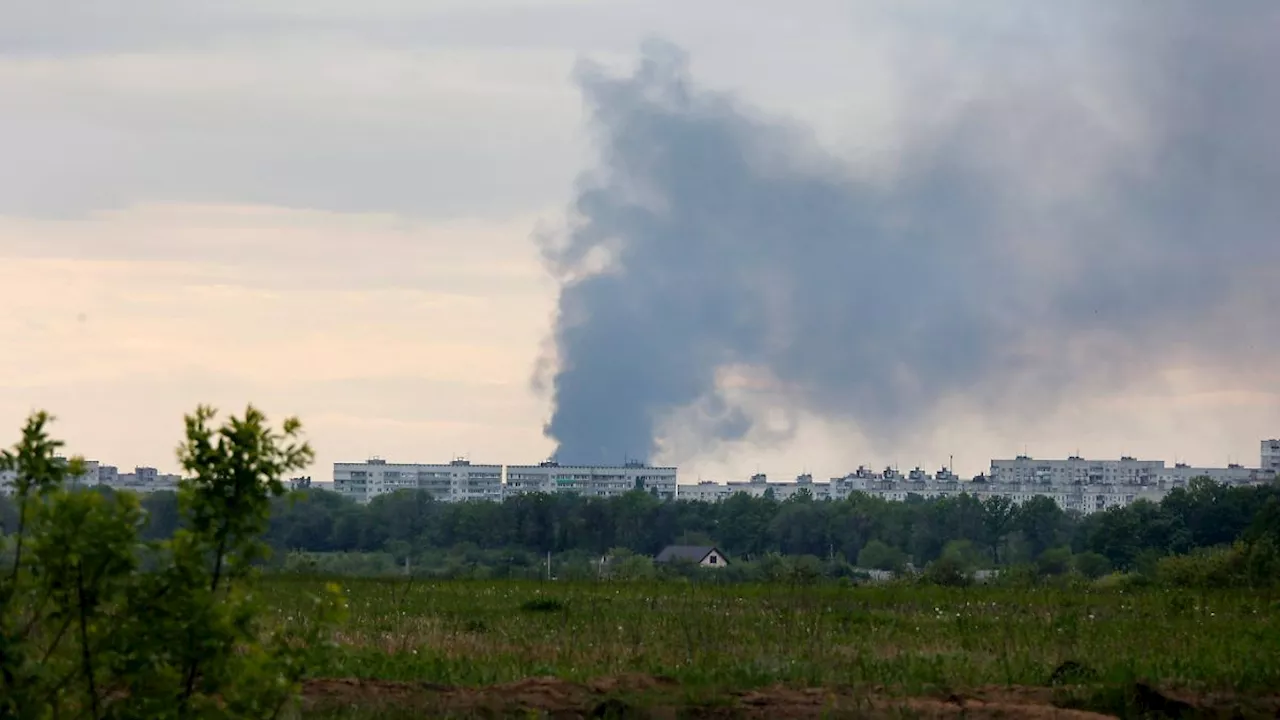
[303,674,1280,720]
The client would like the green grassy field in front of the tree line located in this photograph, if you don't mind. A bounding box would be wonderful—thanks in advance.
[275,578,1280,717]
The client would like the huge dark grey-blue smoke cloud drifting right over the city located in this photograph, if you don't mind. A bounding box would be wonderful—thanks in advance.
[544,1,1280,462]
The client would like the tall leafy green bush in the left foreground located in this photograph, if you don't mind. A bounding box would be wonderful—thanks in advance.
[0,407,343,720]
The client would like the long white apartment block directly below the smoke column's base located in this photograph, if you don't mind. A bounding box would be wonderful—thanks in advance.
[507,462,677,500]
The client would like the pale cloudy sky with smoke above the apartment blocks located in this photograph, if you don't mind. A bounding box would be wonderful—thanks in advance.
[0,0,1280,482]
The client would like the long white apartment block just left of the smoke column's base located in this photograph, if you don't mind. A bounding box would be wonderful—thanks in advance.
[333,457,503,503]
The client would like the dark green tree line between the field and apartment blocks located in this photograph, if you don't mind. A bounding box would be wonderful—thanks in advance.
[0,478,1280,575]
